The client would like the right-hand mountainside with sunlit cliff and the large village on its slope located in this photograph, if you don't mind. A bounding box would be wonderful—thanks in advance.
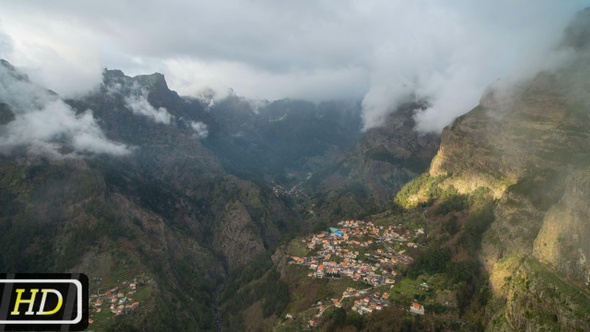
[226,9,590,331]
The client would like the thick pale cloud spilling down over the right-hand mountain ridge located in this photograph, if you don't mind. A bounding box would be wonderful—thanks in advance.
[363,0,584,132]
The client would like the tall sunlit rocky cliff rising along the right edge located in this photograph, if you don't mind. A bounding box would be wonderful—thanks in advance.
[430,10,590,331]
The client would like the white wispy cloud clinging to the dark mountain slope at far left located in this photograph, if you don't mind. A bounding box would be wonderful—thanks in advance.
[0,65,130,157]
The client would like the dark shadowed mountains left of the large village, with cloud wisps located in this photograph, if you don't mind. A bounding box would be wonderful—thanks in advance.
[0,55,438,330]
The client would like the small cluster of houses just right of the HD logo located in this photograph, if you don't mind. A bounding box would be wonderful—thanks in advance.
[88,280,139,324]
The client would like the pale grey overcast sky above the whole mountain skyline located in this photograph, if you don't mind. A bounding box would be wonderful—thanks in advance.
[0,0,590,131]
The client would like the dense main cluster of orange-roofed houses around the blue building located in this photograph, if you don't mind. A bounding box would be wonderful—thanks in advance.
[291,220,424,287]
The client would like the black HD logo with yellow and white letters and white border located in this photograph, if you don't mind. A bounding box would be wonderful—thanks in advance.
[0,273,88,331]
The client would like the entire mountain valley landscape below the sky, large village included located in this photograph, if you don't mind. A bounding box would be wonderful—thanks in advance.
[0,10,590,331]
